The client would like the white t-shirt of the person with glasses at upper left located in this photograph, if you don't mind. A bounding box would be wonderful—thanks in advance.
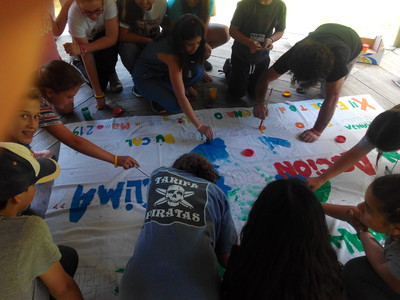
[68,0,118,39]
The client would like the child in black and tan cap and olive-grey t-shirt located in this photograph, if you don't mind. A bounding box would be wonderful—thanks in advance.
[0,143,83,300]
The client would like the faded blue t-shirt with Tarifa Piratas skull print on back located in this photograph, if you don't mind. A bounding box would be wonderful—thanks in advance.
[120,167,236,300]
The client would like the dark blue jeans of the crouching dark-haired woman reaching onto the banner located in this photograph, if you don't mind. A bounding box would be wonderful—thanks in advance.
[135,64,204,113]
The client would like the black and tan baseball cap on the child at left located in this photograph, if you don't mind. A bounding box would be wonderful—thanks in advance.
[0,142,60,202]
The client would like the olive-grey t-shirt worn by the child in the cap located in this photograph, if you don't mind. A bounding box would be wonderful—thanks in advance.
[0,216,61,300]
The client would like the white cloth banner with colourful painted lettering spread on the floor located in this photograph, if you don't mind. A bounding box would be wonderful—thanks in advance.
[46,95,397,300]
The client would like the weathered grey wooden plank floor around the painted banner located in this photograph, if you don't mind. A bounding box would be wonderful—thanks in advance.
[32,33,400,215]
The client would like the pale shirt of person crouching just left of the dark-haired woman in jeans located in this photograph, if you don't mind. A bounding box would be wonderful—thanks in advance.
[119,0,167,37]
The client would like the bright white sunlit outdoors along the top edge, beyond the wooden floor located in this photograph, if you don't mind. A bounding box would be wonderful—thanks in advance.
[54,0,400,47]
